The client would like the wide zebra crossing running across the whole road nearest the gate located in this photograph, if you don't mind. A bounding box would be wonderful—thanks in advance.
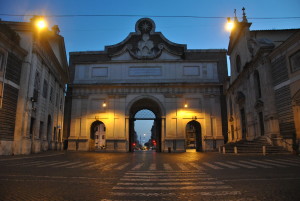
[0,158,300,171]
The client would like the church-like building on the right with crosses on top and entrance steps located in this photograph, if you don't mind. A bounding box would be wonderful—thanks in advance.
[226,9,300,149]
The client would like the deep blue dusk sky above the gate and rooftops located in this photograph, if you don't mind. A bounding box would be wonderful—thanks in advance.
[0,0,300,144]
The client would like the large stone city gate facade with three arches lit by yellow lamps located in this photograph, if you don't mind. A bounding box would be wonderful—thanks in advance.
[66,18,227,152]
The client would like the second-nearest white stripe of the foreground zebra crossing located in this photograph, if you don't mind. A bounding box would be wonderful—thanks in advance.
[112,184,232,191]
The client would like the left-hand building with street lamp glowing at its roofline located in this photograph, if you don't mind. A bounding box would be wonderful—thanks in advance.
[0,18,68,155]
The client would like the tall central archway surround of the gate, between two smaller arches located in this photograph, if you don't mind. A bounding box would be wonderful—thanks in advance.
[128,97,162,152]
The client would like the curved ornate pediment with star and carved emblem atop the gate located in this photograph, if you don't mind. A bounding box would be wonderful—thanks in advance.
[105,18,186,60]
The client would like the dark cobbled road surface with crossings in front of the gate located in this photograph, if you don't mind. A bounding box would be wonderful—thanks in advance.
[0,151,300,201]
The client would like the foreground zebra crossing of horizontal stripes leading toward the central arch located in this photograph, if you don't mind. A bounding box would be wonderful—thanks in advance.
[106,170,242,200]
